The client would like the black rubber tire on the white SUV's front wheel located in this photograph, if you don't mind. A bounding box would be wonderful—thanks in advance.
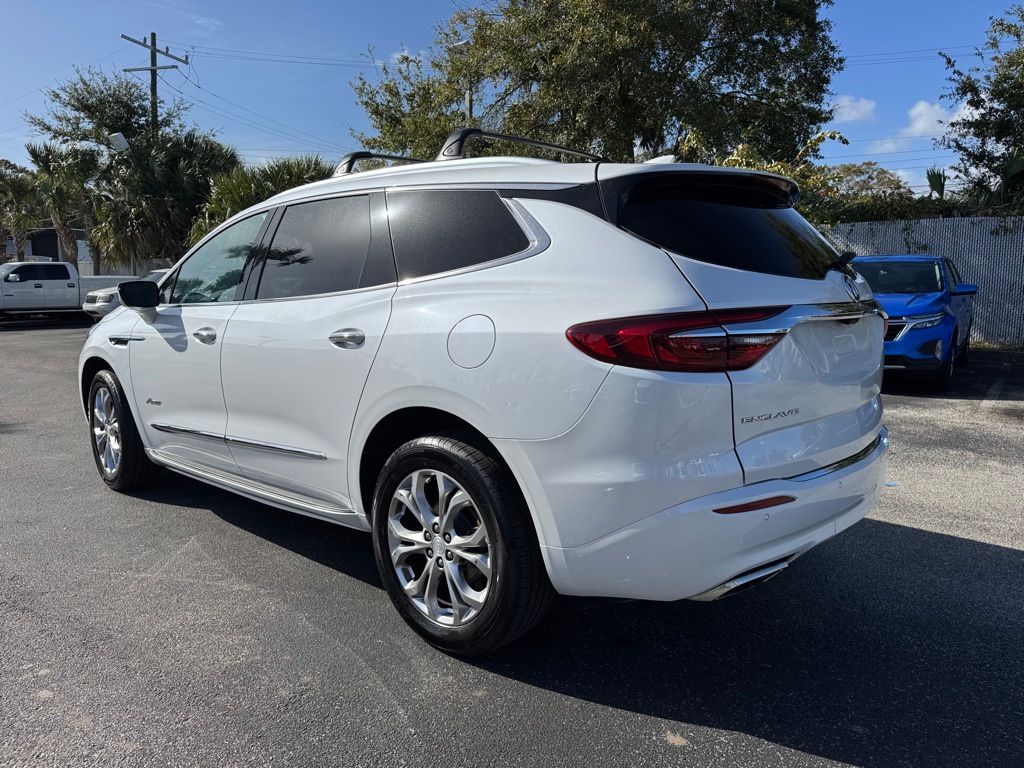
[87,370,160,492]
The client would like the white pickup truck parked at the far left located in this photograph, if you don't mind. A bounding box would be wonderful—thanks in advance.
[0,261,135,317]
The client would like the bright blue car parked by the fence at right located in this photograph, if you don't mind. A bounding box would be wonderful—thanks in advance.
[850,255,978,387]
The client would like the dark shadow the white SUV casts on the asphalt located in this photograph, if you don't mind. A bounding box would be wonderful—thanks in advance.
[132,473,1024,766]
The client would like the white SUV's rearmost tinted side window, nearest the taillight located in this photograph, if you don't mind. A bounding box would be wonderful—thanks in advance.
[387,189,529,280]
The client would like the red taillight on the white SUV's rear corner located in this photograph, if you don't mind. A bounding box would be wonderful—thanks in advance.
[565,307,786,372]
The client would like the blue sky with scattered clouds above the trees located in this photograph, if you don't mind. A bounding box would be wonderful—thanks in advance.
[0,0,1011,190]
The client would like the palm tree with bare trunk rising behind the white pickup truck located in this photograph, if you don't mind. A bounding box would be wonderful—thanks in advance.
[26,143,99,266]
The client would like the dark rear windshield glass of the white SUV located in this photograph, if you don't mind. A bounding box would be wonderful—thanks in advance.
[618,183,839,280]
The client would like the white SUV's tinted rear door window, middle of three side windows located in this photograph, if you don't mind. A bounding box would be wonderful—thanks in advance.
[256,195,370,299]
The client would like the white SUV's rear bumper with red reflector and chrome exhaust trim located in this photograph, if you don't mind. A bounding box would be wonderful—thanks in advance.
[544,427,889,600]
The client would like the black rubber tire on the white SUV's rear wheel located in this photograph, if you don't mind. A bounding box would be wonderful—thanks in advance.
[373,435,554,655]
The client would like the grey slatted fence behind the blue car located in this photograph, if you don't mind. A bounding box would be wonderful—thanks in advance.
[822,217,1024,347]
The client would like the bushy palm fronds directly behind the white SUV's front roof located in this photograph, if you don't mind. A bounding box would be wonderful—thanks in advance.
[191,155,334,243]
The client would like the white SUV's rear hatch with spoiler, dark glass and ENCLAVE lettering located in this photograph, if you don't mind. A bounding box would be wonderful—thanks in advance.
[598,165,884,483]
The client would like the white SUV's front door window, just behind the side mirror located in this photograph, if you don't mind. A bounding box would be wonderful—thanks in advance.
[171,212,266,304]
